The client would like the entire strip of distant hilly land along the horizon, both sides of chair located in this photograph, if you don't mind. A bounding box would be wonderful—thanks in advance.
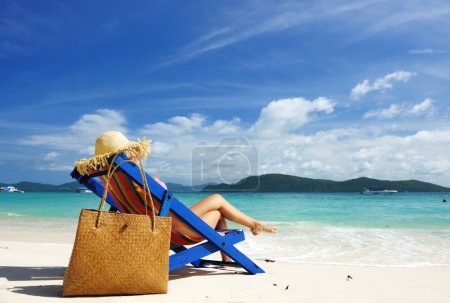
[0,174,450,193]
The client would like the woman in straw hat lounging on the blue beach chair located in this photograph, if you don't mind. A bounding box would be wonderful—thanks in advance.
[76,131,277,261]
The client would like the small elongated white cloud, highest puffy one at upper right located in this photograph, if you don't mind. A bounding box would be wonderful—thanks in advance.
[350,70,416,100]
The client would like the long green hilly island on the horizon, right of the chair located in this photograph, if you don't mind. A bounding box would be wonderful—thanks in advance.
[203,174,450,192]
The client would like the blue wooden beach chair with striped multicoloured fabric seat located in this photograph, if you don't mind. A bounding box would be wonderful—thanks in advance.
[71,153,264,274]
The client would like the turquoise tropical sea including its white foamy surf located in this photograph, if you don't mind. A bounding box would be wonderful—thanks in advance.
[0,192,450,267]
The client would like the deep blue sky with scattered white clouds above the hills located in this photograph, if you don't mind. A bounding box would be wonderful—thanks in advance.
[0,0,450,187]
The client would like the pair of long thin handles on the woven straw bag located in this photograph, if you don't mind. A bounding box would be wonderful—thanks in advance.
[95,151,155,231]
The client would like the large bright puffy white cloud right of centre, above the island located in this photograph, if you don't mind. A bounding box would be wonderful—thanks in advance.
[248,97,334,137]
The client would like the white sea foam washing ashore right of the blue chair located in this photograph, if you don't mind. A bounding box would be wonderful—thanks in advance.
[240,223,450,267]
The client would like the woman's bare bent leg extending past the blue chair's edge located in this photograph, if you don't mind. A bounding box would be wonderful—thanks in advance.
[191,194,277,235]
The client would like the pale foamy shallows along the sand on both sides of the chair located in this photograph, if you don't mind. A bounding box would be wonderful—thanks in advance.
[0,220,450,268]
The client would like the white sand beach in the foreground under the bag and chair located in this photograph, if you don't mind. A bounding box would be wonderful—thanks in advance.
[0,237,450,303]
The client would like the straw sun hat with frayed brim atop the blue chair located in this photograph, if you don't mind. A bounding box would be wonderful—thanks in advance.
[75,131,151,175]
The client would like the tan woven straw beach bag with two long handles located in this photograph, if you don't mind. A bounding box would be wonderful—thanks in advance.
[63,160,171,296]
